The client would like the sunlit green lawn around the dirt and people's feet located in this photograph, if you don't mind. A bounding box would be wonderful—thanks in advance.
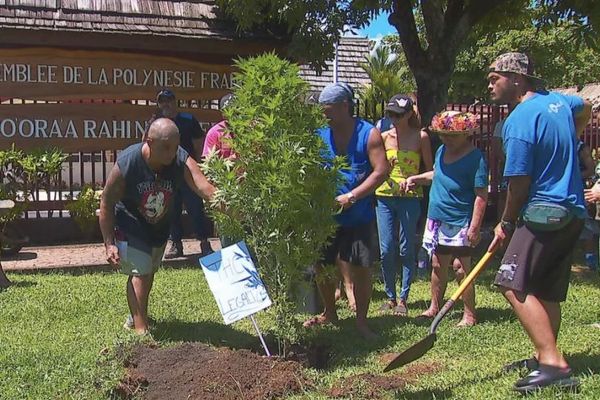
[0,262,600,400]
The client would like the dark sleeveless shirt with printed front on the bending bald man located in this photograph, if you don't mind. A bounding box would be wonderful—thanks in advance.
[115,143,188,247]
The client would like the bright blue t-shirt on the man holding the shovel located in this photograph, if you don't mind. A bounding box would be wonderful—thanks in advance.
[502,92,586,218]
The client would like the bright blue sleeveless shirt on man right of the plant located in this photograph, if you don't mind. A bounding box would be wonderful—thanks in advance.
[317,118,375,226]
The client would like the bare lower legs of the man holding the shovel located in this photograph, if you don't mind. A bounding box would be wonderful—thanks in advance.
[502,288,568,368]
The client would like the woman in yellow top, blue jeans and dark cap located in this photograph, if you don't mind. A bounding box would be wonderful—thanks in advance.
[375,94,433,316]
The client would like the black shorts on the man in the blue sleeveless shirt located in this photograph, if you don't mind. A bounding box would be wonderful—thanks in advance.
[321,222,379,267]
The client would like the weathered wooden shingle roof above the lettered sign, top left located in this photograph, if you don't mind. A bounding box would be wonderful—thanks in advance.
[0,0,281,55]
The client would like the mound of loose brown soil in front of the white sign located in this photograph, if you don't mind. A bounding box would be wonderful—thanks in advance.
[115,343,312,400]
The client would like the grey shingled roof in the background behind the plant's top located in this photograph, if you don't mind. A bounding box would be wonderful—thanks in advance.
[300,37,372,92]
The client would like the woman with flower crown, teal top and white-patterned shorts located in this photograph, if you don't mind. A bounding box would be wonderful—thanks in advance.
[406,111,488,326]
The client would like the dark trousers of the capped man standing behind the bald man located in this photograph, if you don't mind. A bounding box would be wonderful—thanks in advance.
[170,182,212,242]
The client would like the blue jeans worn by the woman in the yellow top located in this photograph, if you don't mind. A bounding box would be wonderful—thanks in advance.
[377,196,421,301]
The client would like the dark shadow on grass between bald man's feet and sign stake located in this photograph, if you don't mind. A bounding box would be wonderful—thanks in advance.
[152,320,260,349]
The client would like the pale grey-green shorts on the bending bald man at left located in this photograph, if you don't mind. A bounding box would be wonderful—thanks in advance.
[115,232,167,276]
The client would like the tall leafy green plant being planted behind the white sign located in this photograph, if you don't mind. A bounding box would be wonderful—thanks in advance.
[203,54,341,350]
